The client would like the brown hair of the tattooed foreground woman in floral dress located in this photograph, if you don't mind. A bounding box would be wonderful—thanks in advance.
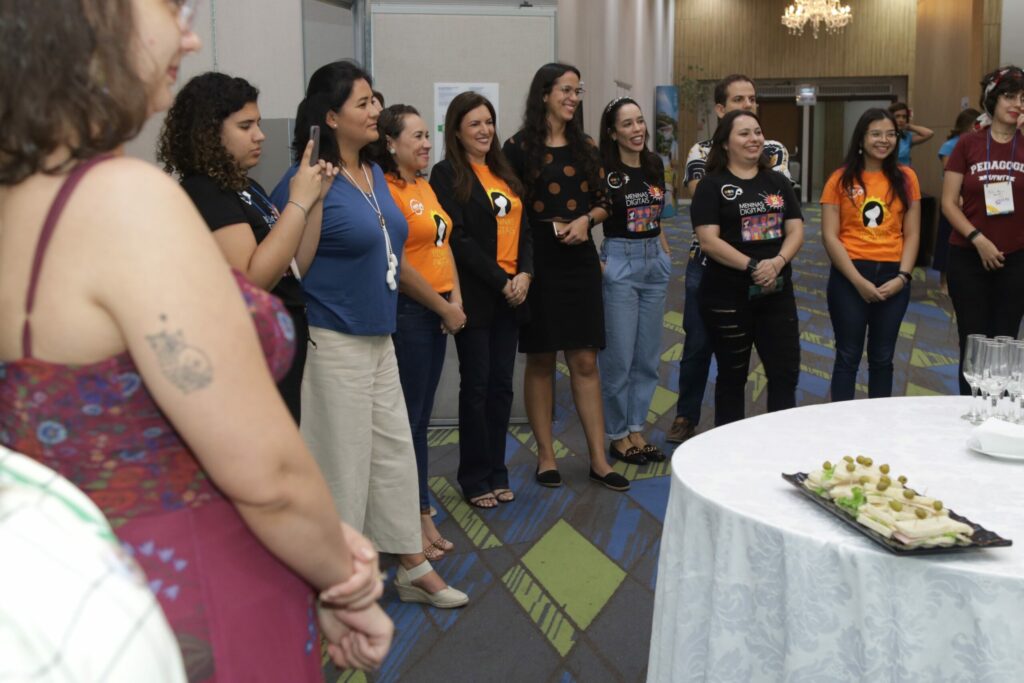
[0,0,150,185]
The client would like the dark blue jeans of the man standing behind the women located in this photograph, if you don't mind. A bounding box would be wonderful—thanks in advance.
[676,253,714,425]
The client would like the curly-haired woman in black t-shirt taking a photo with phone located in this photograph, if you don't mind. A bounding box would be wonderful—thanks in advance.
[158,72,336,422]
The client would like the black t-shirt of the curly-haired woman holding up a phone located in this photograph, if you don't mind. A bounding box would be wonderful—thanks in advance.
[181,175,305,308]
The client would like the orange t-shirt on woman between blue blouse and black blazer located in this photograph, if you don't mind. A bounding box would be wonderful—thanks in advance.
[387,173,455,294]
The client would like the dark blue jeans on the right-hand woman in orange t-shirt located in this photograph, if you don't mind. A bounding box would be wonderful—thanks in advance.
[826,260,910,400]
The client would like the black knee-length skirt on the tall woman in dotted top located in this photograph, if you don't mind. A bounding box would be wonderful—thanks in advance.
[519,221,604,353]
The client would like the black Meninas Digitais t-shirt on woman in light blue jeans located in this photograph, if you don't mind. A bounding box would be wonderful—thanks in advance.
[604,158,665,240]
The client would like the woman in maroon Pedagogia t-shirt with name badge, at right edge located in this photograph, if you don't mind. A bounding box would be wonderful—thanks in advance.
[942,67,1024,394]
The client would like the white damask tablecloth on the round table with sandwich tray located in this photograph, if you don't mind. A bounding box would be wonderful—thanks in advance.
[648,397,1024,683]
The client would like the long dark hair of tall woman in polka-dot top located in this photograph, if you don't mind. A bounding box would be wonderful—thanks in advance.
[515,62,600,196]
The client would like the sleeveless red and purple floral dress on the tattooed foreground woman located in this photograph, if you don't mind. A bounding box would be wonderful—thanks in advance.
[0,156,323,682]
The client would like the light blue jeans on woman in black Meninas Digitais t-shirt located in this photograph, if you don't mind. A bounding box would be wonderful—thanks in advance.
[597,238,672,439]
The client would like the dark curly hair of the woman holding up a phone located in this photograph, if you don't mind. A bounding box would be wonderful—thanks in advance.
[157,72,259,190]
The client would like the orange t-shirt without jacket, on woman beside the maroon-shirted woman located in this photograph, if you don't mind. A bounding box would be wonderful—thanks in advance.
[821,165,921,261]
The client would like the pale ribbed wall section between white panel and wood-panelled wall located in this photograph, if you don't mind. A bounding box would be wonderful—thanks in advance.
[558,0,675,138]
